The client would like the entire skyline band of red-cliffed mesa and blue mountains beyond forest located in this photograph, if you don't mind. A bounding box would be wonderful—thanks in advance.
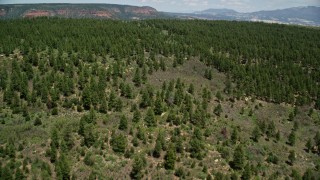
[0,4,320,26]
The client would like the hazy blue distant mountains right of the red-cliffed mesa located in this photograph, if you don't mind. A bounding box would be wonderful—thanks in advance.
[174,6,320,26]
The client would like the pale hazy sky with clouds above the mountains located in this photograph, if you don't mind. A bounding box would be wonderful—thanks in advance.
[0,0,320,12]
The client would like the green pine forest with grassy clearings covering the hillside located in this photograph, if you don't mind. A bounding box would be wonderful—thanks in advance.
[0,18,320,180]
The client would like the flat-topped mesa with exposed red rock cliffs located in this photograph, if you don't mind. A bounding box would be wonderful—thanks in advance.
[0,4,164,19]
